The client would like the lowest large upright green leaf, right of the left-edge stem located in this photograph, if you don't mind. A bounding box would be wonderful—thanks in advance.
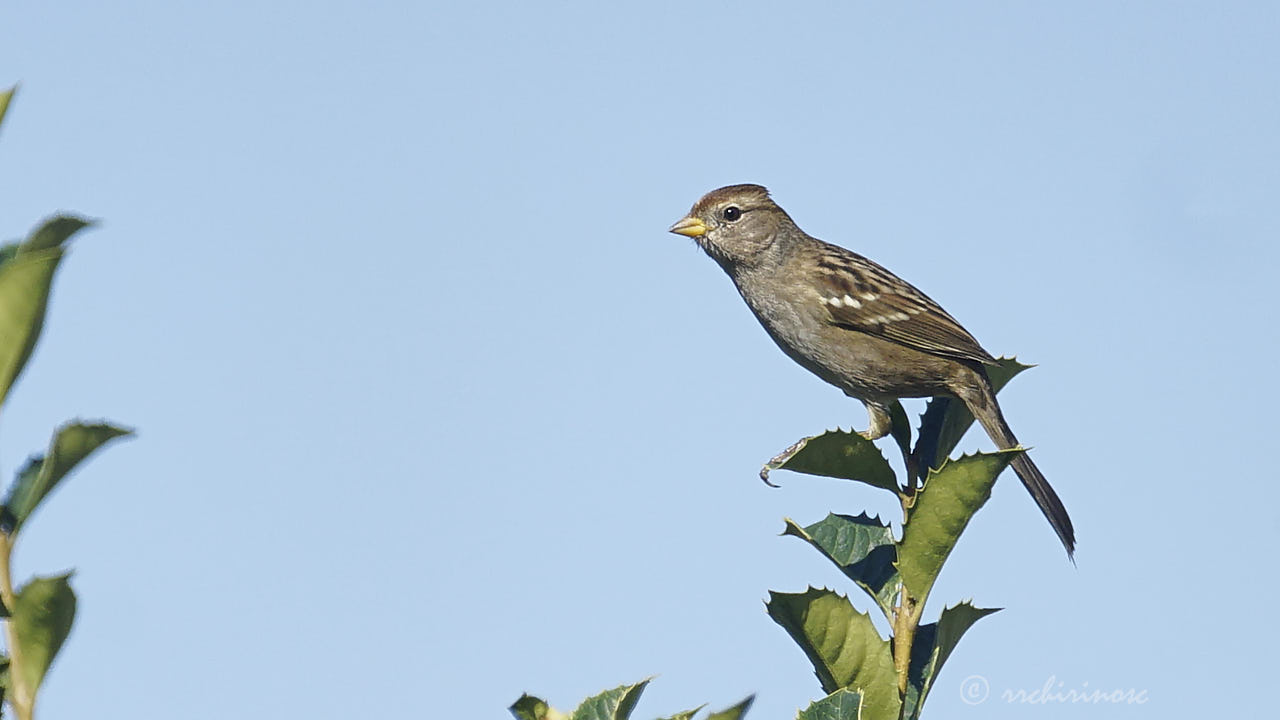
[10,573,76,697]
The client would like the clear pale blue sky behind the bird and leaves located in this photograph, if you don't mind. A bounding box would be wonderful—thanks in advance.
[0,1,1280,720]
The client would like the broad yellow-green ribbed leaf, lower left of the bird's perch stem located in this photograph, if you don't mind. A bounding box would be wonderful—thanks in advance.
[767,588,901,719]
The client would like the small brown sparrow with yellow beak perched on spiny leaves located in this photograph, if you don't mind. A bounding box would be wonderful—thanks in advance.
[669,184,1075,560]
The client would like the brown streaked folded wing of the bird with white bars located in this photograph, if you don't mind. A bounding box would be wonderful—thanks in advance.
[814,243,995,364]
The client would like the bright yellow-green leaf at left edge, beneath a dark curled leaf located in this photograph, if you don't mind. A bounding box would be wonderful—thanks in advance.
[0,249,63,402]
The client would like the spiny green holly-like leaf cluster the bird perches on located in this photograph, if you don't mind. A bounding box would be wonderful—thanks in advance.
[762,359,1028,720]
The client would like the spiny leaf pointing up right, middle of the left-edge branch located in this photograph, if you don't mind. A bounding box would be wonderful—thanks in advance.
[3,423,133,532]
